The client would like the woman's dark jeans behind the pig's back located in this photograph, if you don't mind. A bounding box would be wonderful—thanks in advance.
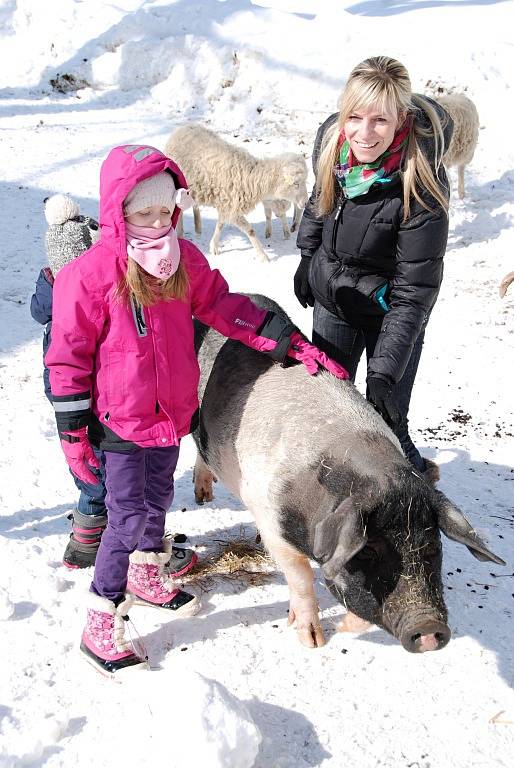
[312,302,426,472]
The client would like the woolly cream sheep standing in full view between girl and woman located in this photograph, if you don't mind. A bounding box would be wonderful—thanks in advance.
[164,123,307,261]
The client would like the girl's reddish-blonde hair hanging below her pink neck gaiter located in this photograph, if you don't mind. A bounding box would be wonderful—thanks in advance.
[116,257,189,307]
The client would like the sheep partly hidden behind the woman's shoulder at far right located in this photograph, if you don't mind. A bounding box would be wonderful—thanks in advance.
[436,93,480,198]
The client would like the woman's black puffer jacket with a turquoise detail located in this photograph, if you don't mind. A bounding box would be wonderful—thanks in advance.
[297,97,453,381]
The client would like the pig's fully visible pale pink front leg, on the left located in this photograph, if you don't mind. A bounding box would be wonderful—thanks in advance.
[265,539,325,648]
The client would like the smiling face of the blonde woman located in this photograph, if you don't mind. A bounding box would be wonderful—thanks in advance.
[343,107,400,163]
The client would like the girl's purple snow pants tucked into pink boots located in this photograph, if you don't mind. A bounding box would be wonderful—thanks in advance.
[91,445,179,603]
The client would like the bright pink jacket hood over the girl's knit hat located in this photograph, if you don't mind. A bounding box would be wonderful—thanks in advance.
[100,144,187,252]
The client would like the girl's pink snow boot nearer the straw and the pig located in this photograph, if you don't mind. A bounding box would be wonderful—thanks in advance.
[127,551,200,617]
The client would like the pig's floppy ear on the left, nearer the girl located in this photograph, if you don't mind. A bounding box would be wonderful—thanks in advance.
[313,497,367,579]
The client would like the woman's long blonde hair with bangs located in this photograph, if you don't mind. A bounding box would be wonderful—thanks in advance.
[316,56,448,221]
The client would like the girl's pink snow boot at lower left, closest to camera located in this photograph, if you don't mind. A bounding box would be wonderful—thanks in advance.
[80,592,148,678]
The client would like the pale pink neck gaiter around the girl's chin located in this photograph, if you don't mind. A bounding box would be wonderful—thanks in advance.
[125,221,180,280]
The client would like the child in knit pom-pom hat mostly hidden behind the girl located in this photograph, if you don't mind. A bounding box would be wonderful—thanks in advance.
[30,195,197,576]
